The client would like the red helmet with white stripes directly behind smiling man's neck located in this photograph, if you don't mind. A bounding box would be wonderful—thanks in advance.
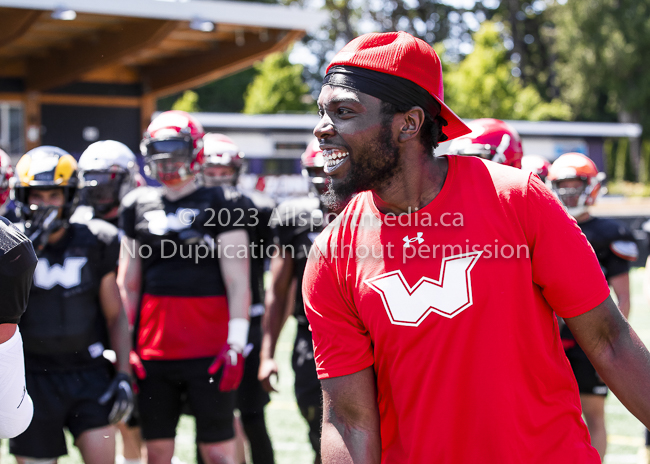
[449,118,524,168]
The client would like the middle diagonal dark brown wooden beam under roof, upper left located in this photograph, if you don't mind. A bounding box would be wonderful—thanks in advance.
[26,20,178,91]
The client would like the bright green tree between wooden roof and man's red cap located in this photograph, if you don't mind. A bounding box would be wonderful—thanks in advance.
[244,52,316,114]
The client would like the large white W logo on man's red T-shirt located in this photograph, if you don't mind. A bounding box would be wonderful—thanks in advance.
[364,251,483,327]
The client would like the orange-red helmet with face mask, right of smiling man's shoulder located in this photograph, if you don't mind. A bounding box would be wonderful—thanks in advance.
[546,153,605,217]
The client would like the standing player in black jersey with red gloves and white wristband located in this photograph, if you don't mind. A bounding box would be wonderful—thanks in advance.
[118,111,254,464]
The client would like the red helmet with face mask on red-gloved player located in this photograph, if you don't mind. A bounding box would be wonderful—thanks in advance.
[140,111,205,186]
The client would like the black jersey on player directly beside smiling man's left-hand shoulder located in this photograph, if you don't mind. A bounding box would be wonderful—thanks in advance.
[272,197,325,325]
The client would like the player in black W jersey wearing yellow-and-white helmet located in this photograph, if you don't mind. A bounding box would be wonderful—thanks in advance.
[10,146,133,464]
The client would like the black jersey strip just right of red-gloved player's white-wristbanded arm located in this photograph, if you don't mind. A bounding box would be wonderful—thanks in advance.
[243,190,275,317]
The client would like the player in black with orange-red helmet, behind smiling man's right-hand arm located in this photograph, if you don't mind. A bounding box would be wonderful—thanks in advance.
[547,153,639,459]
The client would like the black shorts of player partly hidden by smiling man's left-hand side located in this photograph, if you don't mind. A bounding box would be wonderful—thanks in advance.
[291,324,321,409]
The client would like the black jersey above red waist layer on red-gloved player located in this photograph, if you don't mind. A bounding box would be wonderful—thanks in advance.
[120,187,251,297]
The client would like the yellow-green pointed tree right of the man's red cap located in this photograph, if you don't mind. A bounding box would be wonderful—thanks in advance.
[443,21,571,121]
